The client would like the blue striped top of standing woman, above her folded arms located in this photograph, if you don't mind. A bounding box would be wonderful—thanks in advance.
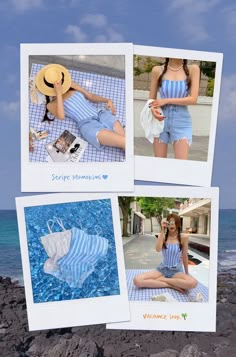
[160,79,188,98]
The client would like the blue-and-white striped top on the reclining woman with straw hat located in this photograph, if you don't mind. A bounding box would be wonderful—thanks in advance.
[64,91,98,124]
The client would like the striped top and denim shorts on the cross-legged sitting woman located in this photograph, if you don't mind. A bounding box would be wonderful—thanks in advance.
[156,243,184,278]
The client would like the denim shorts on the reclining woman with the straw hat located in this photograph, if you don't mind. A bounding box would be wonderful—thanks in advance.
[79,110,118,150]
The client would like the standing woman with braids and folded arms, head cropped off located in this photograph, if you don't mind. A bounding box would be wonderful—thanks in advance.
[149,58,200,160]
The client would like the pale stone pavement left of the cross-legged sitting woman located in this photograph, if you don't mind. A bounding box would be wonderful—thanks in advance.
[123,235,162,269]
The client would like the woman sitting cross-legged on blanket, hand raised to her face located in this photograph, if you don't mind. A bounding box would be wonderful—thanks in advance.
[134,214,197,292]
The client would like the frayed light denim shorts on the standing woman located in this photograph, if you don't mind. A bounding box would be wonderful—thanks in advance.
[159,104,192,145]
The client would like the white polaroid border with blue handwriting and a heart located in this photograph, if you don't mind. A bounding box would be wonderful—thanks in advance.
[21,43,134,192]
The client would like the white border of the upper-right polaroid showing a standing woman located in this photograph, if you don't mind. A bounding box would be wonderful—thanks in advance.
[134,45,223,186]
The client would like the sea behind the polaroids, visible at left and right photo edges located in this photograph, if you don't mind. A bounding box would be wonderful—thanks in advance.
[0,209,236,285]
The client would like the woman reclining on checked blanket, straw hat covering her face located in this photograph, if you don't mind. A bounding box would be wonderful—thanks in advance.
[35,64,125,149]
